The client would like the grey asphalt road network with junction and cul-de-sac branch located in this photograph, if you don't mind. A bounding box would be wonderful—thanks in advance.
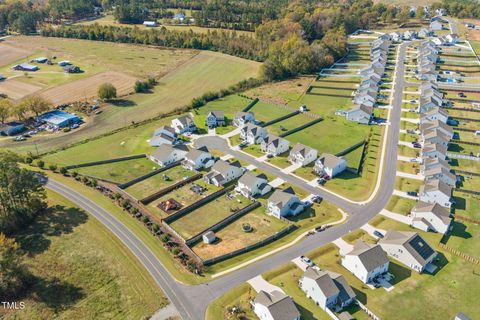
[46,43,408,320]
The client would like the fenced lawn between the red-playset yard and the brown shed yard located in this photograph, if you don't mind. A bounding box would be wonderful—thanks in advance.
[170,195,252,239]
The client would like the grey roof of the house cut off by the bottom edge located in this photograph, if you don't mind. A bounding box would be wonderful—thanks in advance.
[254,290,300,320]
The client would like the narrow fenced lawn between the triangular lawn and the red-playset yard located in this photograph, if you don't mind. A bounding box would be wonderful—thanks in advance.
[125,166,195,200]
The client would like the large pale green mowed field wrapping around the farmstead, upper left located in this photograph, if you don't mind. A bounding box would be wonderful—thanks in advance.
[1,38,260,153]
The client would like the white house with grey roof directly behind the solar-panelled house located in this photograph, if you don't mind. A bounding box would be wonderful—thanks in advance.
[410,201,452,234]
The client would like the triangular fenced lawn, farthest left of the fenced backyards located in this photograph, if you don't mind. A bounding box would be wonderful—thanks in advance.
[71,158,158,183]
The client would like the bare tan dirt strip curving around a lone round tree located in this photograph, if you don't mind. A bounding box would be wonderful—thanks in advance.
[42,71,137,105]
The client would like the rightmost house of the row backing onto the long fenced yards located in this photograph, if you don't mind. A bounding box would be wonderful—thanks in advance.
[267,188,304,218]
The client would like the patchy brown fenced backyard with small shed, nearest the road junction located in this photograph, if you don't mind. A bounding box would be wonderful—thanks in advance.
[192,207,288,259]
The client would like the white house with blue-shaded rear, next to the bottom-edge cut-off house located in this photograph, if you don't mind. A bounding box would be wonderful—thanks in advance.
[298,268,355,310]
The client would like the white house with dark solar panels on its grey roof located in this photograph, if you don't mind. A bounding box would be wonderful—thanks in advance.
[378,230,437,273]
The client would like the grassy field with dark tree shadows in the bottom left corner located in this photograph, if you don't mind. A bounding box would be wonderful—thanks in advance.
[0,192,168,319]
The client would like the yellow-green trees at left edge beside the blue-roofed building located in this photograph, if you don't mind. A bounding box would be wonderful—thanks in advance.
[0,95,52,123]
